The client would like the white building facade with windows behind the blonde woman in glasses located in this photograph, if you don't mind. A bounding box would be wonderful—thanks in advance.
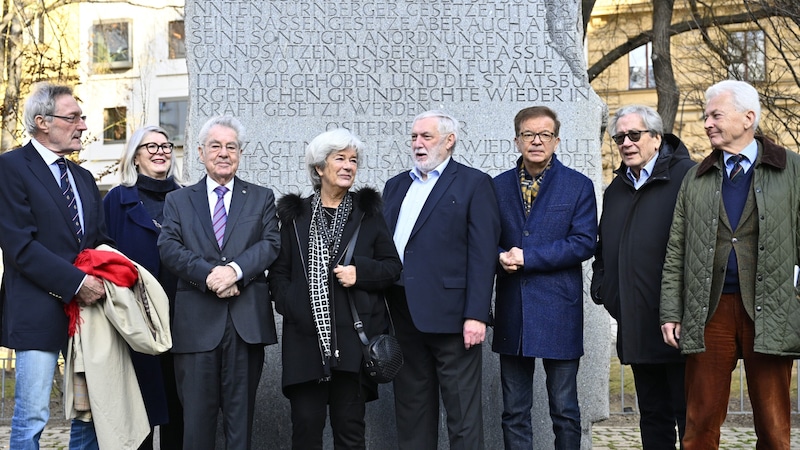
[76,0,189,191]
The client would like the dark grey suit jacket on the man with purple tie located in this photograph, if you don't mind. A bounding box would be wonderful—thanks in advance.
[158,177,280,353]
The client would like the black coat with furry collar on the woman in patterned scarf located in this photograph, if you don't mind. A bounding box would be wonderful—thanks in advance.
[269,188,402,391]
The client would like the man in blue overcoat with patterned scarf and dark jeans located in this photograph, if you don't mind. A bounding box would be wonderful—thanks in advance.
[492,106,597,450]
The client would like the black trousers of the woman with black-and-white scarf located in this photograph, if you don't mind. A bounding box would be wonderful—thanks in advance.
[284,370,366,450]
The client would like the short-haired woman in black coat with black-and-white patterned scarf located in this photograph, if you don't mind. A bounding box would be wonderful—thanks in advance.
[269,129,402,450]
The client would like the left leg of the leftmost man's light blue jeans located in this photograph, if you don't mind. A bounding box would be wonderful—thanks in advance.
[10,350,58,450]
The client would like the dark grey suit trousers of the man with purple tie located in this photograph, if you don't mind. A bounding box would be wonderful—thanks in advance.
[174,315,264,450]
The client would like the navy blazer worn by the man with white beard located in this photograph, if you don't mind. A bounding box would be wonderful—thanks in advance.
[383,159,500,333]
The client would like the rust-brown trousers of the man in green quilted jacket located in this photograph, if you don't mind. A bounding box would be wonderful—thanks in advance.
[683,294,793,450]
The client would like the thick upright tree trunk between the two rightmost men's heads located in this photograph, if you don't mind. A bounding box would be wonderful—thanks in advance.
[652,0,680,133]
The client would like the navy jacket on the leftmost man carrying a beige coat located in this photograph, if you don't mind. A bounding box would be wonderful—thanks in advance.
[0,143,112,351]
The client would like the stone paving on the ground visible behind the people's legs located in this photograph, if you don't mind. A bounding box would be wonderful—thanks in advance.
[0,425,800,450]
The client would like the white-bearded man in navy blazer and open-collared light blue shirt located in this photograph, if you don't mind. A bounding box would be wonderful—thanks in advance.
[383,111,500,450]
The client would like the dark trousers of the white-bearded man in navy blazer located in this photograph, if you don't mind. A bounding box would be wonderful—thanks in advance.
[389,286,484,450]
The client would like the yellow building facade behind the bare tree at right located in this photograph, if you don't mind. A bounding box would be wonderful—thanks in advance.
[587,0,800,182]
